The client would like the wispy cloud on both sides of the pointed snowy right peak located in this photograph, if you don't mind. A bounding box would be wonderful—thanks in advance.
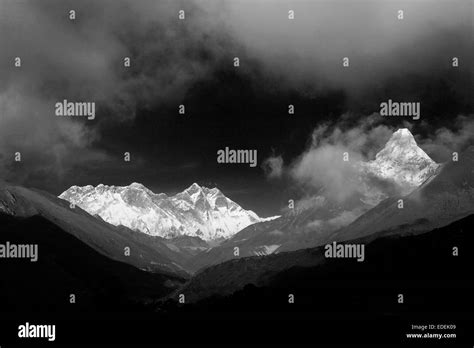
[264,114,474,209]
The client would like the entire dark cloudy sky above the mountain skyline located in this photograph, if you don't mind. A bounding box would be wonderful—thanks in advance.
[0,0,474,216]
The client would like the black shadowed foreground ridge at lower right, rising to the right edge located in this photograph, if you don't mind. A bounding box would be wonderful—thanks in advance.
[175,212,474,308]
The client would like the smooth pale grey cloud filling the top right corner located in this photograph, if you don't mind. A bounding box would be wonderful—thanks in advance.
[223,0,472,98]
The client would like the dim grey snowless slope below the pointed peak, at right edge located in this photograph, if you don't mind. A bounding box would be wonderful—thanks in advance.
[332,146,474,240]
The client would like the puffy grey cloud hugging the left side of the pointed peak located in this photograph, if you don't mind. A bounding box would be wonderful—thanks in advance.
[265,114,418,204]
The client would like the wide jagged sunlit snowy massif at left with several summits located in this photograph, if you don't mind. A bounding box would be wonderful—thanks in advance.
[59,183,265,241]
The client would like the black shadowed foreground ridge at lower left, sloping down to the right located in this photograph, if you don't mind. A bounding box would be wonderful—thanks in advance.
[0,213,184,313]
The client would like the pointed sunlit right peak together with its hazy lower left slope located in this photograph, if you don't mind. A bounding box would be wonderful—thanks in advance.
[290,128,441,222]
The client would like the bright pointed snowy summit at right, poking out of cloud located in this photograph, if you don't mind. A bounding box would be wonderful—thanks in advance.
[362,128,440,194]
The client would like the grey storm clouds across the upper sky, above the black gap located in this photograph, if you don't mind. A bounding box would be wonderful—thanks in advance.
[0,0,472,193]
